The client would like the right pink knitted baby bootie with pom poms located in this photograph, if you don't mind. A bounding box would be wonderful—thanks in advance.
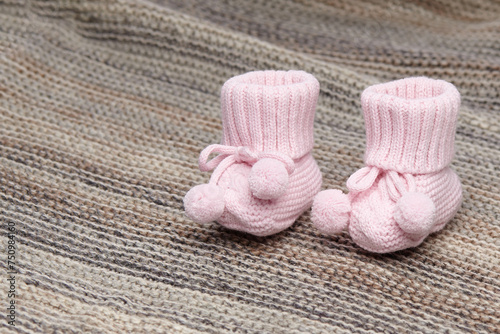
[312,77,462,253]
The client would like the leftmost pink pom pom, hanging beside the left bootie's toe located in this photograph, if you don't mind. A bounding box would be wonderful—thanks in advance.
[184,184,225,224]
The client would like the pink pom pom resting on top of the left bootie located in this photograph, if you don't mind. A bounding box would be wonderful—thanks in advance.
[248,158,288,199]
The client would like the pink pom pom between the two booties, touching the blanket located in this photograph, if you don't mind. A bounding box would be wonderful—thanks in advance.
[311,189,351,234]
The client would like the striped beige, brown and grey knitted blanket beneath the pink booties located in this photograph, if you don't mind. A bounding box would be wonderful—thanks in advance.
[0,0,500,334]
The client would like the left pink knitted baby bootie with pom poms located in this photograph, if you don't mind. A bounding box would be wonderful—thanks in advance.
[184,71,321,236]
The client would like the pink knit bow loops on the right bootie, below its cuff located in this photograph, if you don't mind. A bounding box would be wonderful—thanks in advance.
[347,166,416,201]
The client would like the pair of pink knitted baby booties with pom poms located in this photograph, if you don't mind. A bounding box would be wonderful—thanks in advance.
[184,71,462,253]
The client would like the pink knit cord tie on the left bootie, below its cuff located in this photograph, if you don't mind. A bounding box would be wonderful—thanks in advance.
[198,144,295,175]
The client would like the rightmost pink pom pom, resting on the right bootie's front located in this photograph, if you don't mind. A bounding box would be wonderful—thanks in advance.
[394,192,436,235]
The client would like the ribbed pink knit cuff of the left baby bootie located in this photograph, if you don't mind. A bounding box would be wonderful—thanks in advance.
[221,71,319,159]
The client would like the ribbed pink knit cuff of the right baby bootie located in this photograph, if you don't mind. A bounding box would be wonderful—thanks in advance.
[361,77,460,174]
